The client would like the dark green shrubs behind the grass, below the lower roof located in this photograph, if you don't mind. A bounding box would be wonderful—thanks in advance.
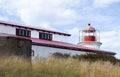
[52,52,120,64]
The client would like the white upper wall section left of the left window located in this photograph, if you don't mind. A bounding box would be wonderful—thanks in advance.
[0,24,16,35]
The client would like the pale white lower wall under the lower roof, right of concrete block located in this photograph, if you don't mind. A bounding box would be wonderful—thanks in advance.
[32,45,86,59]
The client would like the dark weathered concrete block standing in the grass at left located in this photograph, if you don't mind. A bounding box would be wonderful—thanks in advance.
[0,37,32,58]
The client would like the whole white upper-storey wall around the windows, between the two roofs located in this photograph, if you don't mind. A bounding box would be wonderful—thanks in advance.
[0,24,69,42]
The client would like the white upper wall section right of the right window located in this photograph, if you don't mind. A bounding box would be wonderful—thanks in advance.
[52,34,69,42]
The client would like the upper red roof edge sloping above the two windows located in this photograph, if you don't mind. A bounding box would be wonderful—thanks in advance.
[0,21,71,36]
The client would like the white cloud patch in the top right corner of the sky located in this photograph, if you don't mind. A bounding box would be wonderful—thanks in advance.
[93,0,120,7]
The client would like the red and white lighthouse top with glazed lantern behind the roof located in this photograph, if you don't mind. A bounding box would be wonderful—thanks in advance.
[78,24,102,49]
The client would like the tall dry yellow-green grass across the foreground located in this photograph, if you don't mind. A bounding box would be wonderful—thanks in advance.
[0,57,120,77]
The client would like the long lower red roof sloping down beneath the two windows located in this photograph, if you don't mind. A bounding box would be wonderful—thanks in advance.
[0,33,116,55]
